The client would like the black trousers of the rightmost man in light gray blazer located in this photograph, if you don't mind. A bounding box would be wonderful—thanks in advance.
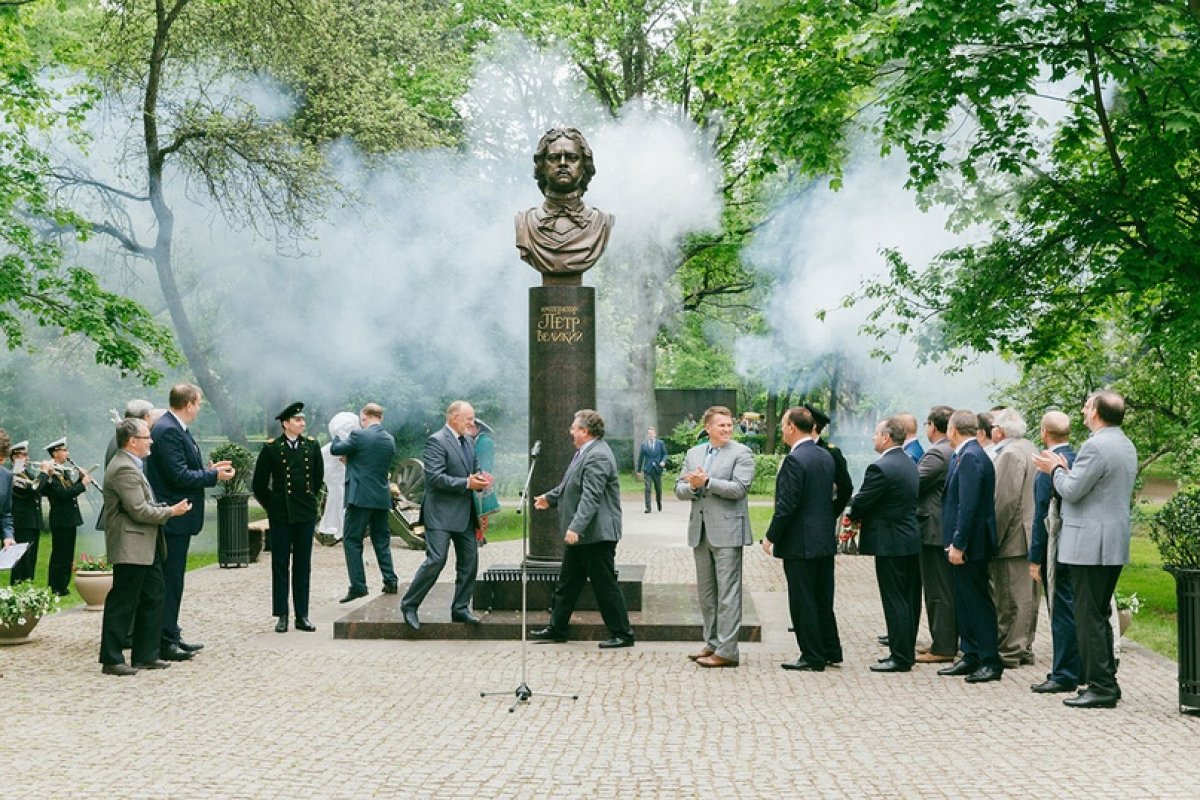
[1070,564,1122,694]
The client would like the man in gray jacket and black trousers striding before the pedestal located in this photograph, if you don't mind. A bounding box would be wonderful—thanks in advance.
[529,409,634,649]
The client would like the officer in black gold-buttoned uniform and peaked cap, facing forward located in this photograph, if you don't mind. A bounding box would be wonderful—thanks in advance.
[251,403,325,633]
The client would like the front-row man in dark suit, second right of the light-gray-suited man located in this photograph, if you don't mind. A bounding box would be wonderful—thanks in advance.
[848,416,920,672]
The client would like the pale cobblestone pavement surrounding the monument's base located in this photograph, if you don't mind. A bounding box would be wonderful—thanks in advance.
[0,499,1200,799]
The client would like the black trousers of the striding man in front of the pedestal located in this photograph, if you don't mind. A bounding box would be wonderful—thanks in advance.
[550,542,634,640]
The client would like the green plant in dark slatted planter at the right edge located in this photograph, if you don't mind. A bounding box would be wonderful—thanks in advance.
[1150,486,1200,710]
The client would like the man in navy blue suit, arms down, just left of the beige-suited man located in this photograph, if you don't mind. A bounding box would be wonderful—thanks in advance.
[937,409,1004,684]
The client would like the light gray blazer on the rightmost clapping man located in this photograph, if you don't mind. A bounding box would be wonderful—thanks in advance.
[1052,427,1138,566]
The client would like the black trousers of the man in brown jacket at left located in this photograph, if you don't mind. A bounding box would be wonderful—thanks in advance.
[100,559,166,664]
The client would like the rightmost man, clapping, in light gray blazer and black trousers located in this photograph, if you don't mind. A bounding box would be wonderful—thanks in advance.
[1033,391,1138,709]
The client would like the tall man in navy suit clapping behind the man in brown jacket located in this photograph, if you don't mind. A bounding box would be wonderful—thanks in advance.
[145,384,234,661]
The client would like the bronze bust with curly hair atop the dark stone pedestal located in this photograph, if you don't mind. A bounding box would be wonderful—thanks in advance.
[516,128,613,285]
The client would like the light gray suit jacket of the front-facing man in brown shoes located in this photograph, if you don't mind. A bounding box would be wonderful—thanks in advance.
[676,441,754,547]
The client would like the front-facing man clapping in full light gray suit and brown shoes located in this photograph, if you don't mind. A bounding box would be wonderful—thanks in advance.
[676,405,754,667]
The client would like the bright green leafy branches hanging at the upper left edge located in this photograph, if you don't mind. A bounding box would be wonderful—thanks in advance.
[0,4,179,383]
